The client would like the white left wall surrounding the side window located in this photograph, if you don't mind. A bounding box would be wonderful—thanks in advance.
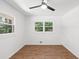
[0,0,24,59]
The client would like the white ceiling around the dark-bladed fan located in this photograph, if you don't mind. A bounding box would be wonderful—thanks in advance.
[4,0,79,16]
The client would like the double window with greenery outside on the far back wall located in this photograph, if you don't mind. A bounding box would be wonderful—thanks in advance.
[35,22,53,32]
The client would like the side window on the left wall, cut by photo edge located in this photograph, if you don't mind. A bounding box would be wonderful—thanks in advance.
[0,15,14,34]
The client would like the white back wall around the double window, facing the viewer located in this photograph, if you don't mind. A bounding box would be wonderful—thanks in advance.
[25,16,62,45]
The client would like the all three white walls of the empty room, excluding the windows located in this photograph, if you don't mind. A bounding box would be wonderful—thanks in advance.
[0,0,79,59]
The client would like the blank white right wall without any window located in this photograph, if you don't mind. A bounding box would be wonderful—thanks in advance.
[63,6,79,57]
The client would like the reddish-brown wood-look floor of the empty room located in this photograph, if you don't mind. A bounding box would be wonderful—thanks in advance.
[10,45,78,59]
